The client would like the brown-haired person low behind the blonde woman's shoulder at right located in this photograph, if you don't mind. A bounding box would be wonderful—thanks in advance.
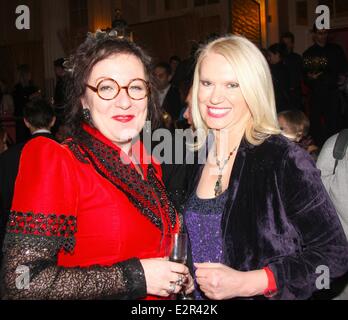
[278,110,319,161]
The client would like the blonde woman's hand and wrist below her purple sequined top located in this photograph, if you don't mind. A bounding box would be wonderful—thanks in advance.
[194,263,268,300]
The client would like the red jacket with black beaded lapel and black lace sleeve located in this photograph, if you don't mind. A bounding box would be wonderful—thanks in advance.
[4,125,180,299]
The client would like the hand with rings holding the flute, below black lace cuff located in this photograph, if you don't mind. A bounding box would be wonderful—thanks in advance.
[140,258,193,297]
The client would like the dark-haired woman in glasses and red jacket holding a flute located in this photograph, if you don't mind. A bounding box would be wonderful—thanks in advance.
[2,32,192,299]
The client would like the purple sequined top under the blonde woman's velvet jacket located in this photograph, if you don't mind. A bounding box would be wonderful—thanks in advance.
[184,191,228,300]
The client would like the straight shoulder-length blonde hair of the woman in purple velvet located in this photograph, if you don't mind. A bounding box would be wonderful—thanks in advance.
[192,35,280,149]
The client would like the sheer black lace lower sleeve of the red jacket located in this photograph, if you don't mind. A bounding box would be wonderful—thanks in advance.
[1,233,146,300]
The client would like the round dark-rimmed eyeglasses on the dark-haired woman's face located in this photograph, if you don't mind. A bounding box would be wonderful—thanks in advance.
[86,78,150,100]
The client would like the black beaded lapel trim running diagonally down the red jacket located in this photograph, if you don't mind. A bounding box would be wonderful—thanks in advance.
[66,131,177,231]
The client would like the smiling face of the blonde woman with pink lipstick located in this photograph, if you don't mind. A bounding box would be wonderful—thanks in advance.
[198,52,251,130]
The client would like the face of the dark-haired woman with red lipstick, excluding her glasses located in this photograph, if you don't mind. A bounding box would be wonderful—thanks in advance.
[81,53,148,146]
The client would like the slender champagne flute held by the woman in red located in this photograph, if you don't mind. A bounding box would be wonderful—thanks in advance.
[165,233,191,300]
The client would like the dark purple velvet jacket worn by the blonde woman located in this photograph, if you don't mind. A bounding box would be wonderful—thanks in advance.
[189,135,348,299]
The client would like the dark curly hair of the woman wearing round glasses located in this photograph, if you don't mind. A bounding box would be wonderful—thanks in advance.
[64,31,160,135]
